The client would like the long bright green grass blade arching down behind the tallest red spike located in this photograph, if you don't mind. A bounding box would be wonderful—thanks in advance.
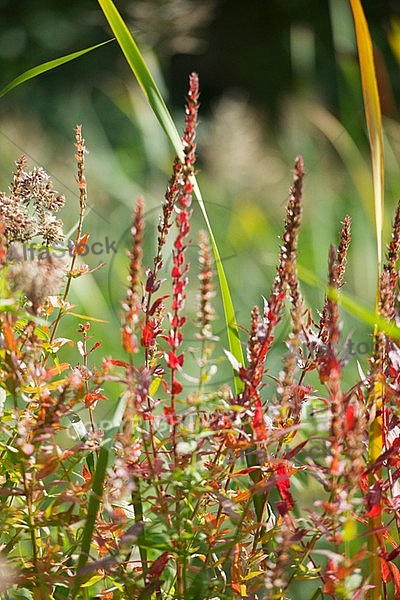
[98,0,244,393]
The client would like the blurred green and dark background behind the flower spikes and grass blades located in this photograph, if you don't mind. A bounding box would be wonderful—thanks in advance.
[0,0,400,398]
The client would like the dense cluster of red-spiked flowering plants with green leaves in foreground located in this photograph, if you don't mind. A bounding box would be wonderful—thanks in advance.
[0,74,400,600]
